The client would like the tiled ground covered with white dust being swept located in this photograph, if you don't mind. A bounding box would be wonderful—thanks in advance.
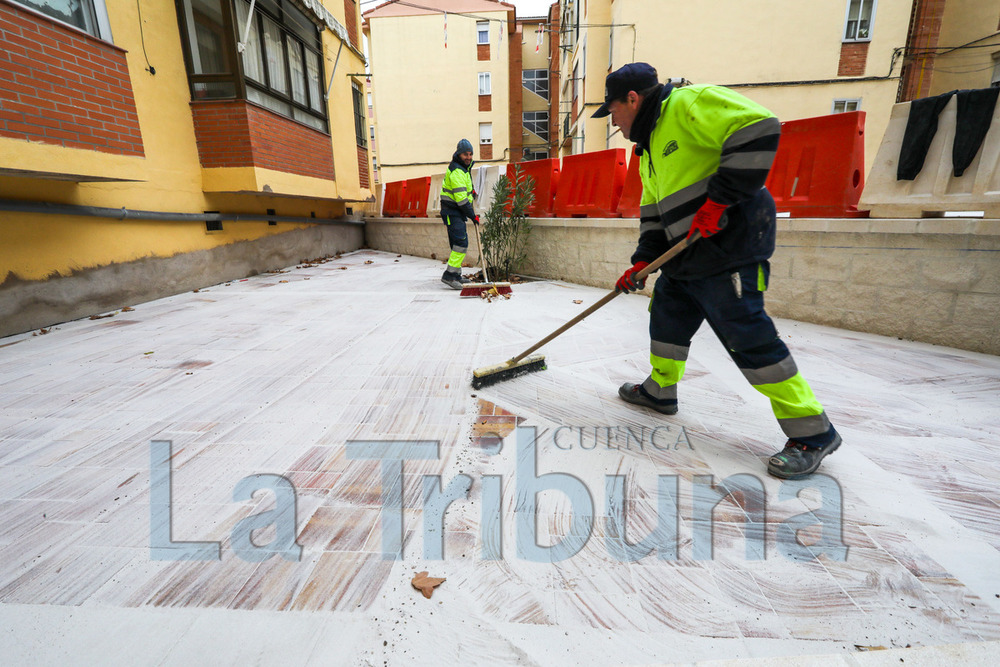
[0,251,1000,666]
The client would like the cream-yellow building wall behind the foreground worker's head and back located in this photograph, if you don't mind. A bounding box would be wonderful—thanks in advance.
[580,0,916,177]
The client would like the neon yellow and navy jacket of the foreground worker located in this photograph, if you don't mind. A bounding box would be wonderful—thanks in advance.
[632,85,781,278]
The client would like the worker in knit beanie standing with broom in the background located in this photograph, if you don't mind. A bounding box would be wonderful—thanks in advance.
[441,139,479,289]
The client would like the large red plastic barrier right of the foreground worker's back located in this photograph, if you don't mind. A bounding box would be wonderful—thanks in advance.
[766,111,868,218]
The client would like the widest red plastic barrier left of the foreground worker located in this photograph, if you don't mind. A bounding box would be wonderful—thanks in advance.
[555,148,626,218]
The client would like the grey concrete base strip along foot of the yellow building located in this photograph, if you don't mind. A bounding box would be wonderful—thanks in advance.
[0,224,364,336]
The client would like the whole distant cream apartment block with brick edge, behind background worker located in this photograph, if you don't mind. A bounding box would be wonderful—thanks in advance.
[363,0,522,182]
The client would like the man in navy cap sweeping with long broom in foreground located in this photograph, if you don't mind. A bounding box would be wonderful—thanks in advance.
[594,63,841,479]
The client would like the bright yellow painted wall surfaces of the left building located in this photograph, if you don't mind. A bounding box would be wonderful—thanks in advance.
[0,0,371,283]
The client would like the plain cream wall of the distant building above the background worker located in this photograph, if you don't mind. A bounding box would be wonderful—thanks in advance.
[368,11,511,182]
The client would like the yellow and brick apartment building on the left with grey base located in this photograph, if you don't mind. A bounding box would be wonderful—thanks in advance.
[0,0,373,335]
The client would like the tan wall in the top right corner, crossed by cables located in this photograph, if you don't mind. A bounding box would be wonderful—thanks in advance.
[929,0,1000,95]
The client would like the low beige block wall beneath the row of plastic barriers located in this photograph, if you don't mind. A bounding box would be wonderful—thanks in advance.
[365,218,1000,354]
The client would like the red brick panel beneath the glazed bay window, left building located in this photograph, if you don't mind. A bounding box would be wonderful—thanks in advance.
[191,100,335,180]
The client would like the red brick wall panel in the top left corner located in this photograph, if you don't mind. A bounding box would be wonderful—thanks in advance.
[0,0,144,155]
